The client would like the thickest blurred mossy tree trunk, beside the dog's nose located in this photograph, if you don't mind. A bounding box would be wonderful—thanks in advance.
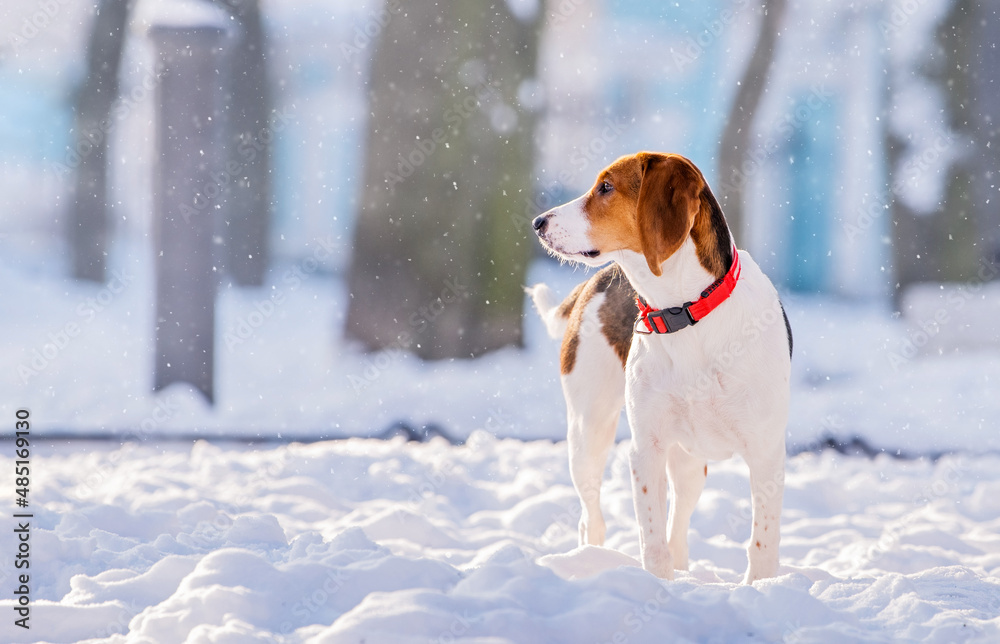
[344,0,543,359]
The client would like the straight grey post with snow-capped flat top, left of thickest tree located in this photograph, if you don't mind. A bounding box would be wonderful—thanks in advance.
[149,24,227,402]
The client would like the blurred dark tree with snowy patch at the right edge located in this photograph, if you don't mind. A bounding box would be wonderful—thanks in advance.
[887,0,1000,304]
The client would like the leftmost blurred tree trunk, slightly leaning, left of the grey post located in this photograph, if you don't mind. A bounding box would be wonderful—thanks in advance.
[68,0,134,282]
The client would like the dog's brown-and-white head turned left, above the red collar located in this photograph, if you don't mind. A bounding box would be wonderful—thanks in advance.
[532,152,731,277]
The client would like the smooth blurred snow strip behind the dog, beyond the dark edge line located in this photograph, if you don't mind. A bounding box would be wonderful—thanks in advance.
[0,252,1000,455]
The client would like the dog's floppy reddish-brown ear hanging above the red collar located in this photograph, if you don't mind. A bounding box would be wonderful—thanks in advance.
[636,154,702,277]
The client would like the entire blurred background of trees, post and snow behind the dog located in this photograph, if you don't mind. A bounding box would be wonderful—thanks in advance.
[0,0,1000,453]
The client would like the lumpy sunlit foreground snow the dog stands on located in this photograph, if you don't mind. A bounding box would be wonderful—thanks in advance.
[0,431,1000,644]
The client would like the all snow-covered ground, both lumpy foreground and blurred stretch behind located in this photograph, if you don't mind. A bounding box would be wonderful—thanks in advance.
[0,253,1000,644]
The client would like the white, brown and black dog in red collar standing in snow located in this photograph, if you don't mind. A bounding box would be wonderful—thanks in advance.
[527,152,792,583]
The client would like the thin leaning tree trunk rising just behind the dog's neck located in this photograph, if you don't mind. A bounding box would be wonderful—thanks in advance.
[716,0,788,243]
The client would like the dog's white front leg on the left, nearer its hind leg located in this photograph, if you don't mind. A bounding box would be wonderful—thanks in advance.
[629,423,674,579]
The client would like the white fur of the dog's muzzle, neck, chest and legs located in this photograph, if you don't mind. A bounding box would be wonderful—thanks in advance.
[540,199,791,583]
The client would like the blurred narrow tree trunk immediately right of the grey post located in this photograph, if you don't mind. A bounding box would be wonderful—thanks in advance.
[214,0,273,286]
